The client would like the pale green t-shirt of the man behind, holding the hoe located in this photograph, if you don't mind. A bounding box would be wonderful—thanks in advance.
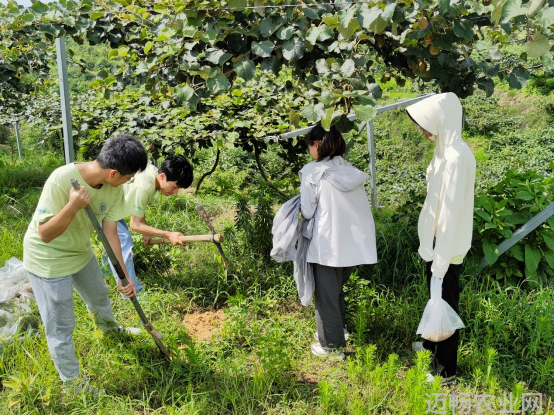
[123,165,158,218]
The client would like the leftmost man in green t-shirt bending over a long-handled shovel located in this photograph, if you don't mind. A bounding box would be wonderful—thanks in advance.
[23,135,148,392]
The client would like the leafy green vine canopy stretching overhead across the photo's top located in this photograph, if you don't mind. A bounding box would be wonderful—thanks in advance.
[0,0,554,128]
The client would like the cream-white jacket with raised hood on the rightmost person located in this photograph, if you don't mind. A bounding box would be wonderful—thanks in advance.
[406,93,476,278]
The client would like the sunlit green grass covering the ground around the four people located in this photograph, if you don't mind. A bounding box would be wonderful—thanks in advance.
[0,81,554,414]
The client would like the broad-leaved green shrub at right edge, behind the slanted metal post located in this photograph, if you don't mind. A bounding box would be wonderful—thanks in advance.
[474,170,554,288]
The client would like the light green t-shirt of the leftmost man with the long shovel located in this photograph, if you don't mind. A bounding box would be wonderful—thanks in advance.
[23,163,126,278]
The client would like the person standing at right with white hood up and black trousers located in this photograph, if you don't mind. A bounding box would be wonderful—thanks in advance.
[406,93,476,381]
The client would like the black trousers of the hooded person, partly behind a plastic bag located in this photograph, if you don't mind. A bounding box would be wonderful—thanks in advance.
[423,262,462,377]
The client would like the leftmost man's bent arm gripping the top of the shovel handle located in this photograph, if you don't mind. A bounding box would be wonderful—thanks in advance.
[38,186,90,244]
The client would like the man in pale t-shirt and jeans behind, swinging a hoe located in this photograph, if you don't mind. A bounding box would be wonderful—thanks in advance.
[103,156,194,293]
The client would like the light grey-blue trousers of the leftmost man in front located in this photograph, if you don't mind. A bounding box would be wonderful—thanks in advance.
[29,256,119,382]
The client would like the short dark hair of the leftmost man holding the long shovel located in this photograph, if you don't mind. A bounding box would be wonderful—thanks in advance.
[96,134,148,175]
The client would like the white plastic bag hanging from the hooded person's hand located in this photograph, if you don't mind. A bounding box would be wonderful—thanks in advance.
[417,276,465,342]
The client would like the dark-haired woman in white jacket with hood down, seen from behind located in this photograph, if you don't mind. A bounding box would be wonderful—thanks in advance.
[299,125,377,359]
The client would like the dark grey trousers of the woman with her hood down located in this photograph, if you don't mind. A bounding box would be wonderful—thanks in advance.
[312,263,354,349]
